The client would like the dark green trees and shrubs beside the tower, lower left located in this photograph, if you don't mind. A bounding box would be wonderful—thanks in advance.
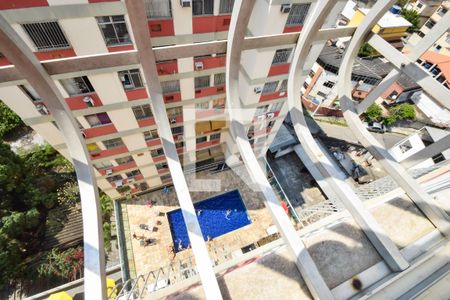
[0,101,113,298]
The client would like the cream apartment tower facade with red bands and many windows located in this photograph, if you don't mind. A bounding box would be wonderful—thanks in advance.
[0,0,310,199]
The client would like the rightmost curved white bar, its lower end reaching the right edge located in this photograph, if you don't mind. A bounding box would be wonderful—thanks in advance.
[338,0,450,236]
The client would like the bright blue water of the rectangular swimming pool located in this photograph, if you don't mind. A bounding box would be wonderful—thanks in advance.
[167,190,251,252]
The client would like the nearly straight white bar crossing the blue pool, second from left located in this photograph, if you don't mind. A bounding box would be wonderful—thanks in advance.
[125,0,222,299]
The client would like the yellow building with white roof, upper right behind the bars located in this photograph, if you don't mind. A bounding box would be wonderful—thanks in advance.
[348,6,412,49]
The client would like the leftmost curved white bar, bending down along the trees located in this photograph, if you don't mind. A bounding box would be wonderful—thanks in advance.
[0,15,106,299]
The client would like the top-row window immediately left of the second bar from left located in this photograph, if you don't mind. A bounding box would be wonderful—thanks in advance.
[97,16,131,46]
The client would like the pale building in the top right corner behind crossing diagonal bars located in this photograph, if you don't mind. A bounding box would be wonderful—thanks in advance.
[405,0,450,55]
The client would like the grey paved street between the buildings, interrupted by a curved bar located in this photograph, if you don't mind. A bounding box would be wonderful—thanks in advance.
[317,122,405,148]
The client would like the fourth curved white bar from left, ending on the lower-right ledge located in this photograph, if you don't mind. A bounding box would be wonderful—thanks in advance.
[288,0,409,271]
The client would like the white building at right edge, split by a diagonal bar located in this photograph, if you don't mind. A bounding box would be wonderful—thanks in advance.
[388,126,450,169]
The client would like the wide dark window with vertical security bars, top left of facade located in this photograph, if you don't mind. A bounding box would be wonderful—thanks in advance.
[22,22,70,50]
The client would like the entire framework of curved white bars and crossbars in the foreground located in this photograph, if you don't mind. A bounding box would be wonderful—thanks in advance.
[0,0,450,299]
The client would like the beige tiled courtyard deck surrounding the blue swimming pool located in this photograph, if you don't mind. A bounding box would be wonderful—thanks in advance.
[123,167,273,275]
